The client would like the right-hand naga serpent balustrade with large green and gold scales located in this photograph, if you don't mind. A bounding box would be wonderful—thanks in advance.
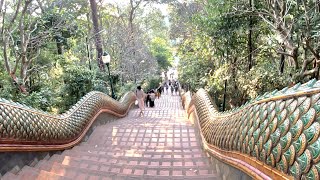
[182,80,320,179]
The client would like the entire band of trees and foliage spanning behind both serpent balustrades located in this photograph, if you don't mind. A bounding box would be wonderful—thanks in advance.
[0,0,320,112]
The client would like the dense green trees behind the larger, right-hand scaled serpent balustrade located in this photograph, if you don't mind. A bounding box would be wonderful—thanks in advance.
[171,0,320,107]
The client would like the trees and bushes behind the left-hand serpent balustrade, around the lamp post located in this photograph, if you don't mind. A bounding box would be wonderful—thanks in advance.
[0,0,170,113]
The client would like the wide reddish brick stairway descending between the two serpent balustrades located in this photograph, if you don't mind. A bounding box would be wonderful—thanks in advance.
[5,95,221,180]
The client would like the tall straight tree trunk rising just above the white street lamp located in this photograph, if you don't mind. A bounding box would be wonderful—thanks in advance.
[90,0,104,71]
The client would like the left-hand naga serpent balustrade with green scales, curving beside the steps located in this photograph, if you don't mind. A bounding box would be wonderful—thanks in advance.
[0,92,135,152]
